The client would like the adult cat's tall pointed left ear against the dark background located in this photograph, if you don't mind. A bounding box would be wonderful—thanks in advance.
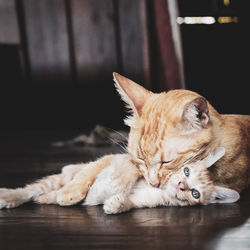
[113,72,150,116]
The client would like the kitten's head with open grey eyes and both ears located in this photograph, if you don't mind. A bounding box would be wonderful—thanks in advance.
[164,147,240,206]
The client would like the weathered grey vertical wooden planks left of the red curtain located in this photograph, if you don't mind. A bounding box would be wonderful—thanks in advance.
[0,0,152,86]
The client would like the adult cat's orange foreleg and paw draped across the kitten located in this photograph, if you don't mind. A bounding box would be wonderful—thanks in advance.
[57,155,114,206]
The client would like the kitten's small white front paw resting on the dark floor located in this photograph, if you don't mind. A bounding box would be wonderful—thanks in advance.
[103,195,127,214]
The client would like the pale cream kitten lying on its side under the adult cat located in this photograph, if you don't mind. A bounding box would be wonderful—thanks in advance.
[0,148,239,214]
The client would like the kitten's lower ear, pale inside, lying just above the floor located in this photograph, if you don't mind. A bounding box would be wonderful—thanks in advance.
[209,186,240,203]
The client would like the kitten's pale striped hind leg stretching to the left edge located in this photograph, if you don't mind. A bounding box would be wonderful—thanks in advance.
[0,174,70,209]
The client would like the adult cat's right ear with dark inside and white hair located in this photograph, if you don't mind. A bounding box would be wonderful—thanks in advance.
[182,96,210,129]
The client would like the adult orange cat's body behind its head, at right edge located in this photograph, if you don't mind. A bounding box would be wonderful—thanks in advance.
[210,115,250,192]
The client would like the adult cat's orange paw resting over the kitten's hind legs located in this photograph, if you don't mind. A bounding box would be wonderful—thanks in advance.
[57,185,89,206]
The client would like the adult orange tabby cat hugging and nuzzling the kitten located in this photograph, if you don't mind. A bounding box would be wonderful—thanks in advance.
[50,73,250,205]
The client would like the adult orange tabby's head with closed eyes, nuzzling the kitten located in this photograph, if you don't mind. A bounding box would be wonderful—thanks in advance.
[114,73,221,187]
